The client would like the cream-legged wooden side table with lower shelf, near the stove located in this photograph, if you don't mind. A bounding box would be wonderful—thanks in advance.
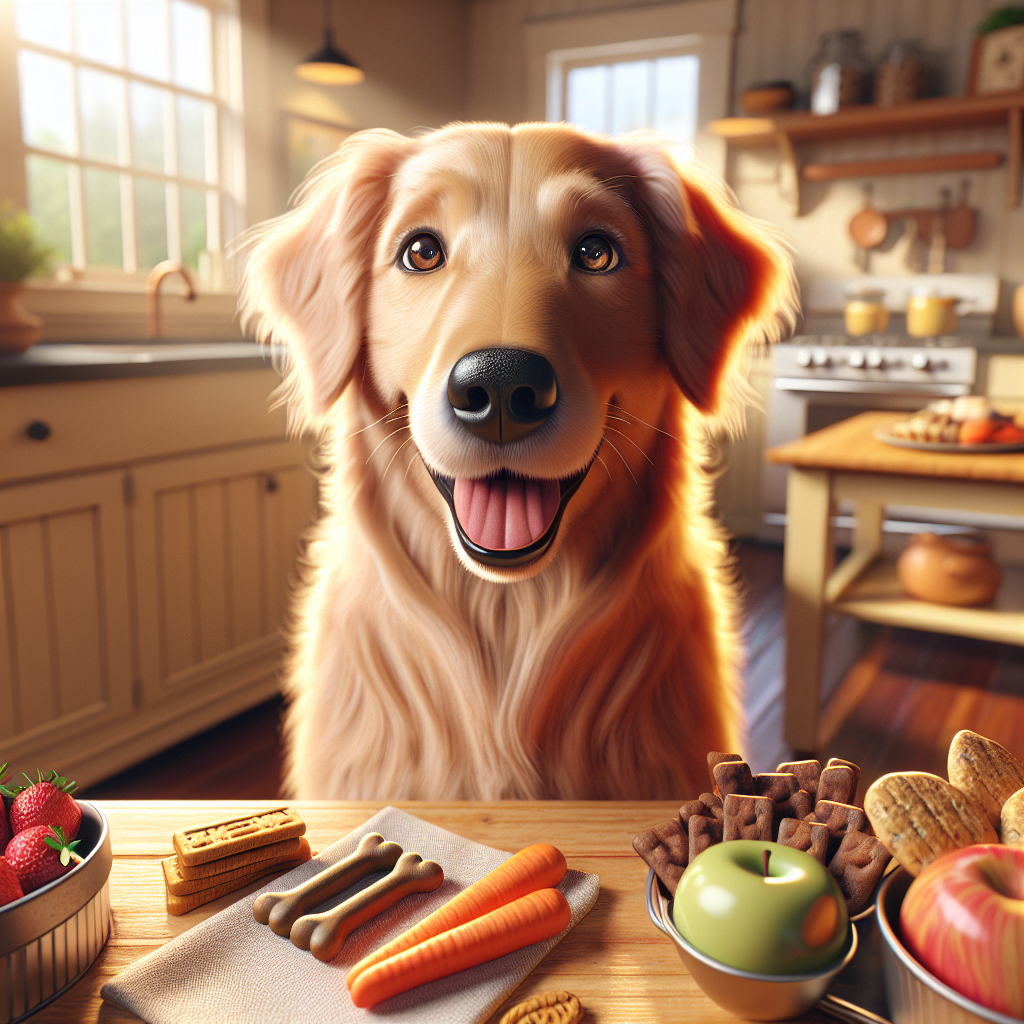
[767,413,1024,752]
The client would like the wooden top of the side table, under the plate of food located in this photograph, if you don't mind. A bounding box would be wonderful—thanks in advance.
[766,413,1024,483]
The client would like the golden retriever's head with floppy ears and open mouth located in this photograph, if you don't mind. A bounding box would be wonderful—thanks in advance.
[241,124,794,580]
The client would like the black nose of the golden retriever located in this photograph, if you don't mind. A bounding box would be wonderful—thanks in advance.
[449,348,558,444]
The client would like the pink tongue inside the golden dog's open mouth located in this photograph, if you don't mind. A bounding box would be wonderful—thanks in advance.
[455,478,561,551]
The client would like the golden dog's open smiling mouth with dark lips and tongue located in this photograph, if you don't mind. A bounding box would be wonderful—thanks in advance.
[430,453,597,568]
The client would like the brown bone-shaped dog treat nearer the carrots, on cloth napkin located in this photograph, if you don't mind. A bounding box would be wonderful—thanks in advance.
[291,853,444,962]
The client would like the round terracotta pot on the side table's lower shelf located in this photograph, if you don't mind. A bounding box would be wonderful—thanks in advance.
[896,534,1002,605]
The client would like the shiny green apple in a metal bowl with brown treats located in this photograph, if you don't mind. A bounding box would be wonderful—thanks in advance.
[672,840,850,974]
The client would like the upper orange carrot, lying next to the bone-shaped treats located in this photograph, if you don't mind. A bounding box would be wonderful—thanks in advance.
[348,843,565,988]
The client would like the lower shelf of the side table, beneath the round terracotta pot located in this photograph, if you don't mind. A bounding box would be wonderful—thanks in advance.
[828,555,1024,646]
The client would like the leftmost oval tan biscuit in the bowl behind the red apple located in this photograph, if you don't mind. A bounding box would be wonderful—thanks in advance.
[864,771,999,876]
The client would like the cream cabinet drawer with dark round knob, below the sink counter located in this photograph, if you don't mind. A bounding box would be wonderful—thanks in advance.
[0,368,286,484]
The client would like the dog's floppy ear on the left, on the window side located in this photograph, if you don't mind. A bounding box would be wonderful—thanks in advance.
[239,129,417,426]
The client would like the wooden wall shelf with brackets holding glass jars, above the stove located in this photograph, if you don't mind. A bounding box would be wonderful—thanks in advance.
[709,91,1024,216]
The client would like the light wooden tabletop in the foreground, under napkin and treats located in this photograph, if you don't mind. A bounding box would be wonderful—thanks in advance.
[39,801,831,1024]
